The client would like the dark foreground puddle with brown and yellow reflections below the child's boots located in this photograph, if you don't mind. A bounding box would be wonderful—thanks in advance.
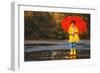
[24,50,90,61]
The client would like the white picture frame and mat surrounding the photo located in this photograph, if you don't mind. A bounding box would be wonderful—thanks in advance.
[11,3,96,70]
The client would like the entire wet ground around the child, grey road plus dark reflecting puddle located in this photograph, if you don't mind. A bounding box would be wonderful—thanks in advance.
[24,40,90,61]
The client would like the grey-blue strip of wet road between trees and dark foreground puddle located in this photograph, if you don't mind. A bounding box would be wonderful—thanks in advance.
[25,40,90,52]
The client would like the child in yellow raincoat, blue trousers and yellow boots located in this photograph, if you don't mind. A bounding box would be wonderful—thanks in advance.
[68,21,79,55]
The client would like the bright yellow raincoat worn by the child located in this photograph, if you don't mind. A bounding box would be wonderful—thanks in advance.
[68,26,79,42]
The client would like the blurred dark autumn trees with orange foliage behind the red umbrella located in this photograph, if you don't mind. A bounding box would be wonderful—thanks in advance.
[24,11,90,40]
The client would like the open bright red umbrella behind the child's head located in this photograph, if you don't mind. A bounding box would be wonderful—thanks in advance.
[62,16,87,33]
